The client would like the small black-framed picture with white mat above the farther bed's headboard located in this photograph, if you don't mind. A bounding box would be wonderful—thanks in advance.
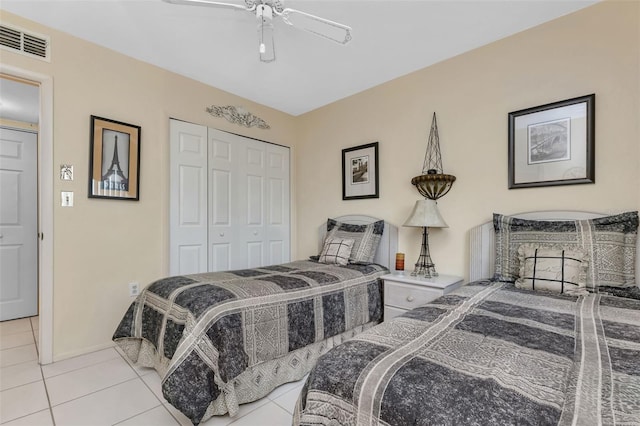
[342,142,379,200]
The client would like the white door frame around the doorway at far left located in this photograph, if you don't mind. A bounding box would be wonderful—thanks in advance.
[0,64,54,364]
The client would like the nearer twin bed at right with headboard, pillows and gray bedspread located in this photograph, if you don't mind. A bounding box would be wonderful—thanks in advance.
[293,212,640,426]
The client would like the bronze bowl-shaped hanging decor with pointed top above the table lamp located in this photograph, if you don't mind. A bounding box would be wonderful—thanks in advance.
[411,112,456,200]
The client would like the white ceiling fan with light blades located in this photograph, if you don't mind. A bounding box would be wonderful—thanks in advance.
[164,0,351,62]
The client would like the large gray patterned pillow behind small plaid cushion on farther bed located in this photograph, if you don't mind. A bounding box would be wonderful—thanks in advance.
[325,219,384,263]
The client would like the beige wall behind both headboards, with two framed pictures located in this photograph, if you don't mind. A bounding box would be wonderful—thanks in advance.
[297,1,640,276]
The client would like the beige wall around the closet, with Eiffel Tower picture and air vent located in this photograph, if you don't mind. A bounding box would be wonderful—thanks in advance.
[0,12,296,359]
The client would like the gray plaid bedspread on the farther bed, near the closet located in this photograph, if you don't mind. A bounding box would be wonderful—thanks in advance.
[113,261,387,424]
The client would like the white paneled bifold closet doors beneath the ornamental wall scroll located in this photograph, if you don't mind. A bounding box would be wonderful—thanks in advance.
[169,119,290,275]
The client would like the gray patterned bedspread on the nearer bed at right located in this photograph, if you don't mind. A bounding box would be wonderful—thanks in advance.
[294,281,640,426]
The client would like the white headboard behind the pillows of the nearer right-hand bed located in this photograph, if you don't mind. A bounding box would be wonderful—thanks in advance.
[469,210,640,287]
